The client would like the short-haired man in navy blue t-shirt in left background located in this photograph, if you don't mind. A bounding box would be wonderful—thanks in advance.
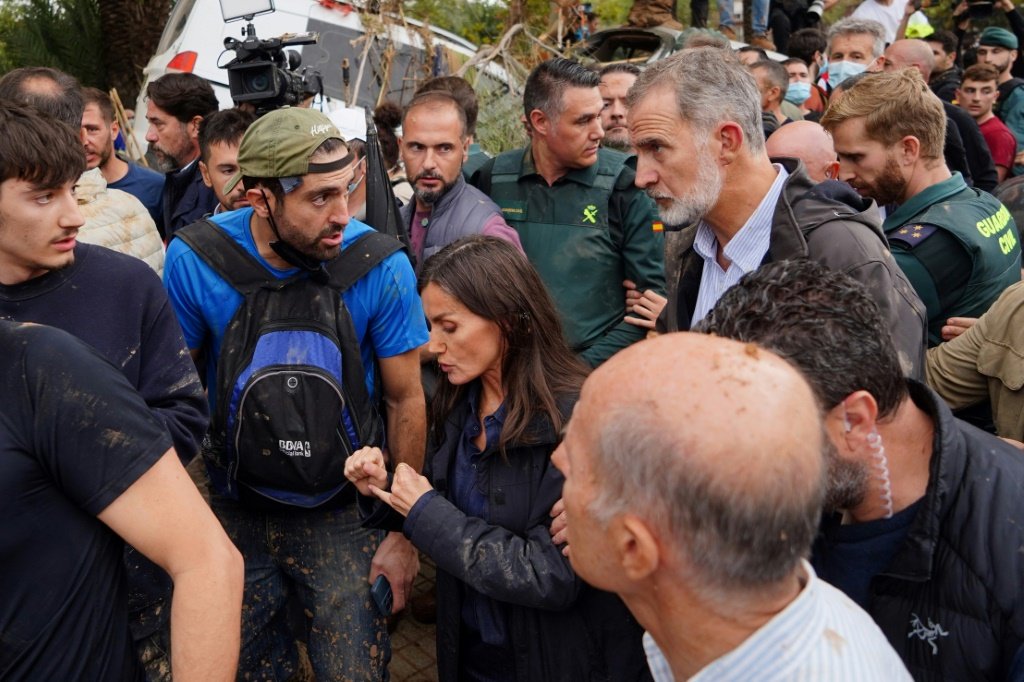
[82,88,164,224]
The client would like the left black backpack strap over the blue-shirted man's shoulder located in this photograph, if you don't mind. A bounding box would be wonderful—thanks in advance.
[174,220,291,295]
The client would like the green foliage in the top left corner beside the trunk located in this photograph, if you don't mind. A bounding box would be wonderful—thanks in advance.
[0,0,106,86]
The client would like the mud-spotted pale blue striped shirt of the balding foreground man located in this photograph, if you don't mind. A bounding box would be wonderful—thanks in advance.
[643,561,911,682]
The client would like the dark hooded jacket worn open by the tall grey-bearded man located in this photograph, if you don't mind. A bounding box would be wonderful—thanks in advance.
[658,159,928,378]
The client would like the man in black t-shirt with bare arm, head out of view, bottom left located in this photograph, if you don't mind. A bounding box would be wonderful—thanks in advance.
[0,319,243,680]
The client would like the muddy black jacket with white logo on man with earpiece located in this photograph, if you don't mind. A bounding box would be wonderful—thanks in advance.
[813,382,1024,682]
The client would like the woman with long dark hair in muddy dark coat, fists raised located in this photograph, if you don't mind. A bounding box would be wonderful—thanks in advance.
[345,236,643,682]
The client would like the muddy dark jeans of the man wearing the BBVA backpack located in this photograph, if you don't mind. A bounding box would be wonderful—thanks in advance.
[211,496,391,682]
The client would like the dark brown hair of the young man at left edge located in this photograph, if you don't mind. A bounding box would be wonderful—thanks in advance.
[0,99,85,188]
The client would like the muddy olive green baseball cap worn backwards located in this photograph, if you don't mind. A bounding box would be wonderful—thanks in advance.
[224,106,355,195]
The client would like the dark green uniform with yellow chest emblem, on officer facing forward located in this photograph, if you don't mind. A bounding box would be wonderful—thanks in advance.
[473,146,665,367]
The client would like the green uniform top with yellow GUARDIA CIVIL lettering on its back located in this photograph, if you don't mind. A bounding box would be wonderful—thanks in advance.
[883,173,1021,345]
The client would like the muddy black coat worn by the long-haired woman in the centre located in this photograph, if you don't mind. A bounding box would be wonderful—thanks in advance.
[364,393,650,682]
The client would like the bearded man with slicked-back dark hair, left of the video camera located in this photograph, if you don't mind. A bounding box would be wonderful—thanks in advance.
[145,73,218,240]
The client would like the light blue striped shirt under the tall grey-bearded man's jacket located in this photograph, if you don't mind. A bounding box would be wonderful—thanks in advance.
[690,164,790,327]
